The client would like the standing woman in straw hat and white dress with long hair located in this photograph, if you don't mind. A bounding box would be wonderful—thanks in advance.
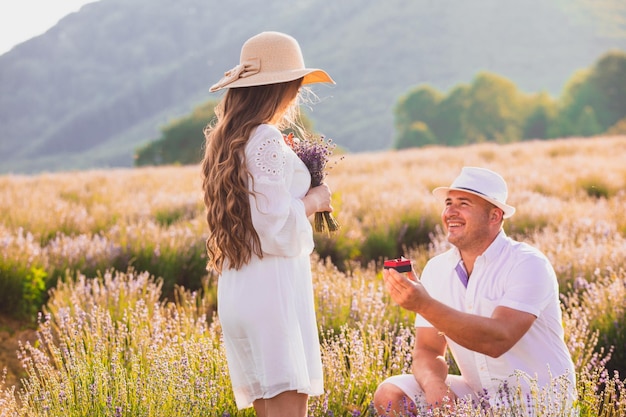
[202,32,334,417]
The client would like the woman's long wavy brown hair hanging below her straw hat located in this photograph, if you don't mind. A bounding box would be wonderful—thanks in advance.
[202,78,302,273]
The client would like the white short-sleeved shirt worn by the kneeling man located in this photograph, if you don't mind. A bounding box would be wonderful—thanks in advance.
[415,231,575,398]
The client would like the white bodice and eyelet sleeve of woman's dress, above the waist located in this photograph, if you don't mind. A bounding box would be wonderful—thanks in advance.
[246,125,313,257]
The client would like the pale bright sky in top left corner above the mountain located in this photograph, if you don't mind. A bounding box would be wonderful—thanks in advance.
[0,0,96,55]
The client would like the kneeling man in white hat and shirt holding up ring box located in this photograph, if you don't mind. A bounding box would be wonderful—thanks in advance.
[374,167,575,416]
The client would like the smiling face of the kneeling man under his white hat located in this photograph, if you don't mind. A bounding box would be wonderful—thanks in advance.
[441,190,496,251]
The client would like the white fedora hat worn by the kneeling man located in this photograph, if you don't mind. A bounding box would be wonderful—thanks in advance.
[433,167,515,219]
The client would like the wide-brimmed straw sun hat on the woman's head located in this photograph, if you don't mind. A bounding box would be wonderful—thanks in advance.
[209,32,335,92]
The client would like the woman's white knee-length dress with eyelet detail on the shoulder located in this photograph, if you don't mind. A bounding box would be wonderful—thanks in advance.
[218,125,323,409]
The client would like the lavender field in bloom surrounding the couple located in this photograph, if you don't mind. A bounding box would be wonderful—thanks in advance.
[0,136,626,417]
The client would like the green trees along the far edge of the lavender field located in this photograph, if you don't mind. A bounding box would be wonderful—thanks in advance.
[135,51,626,166]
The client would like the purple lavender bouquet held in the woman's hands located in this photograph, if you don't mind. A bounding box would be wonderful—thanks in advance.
[284,133,339,232]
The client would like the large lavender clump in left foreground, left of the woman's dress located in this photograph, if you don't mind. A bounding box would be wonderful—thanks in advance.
[7,273,234,416]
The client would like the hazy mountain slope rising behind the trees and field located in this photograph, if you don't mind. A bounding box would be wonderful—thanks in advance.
[0,0,626,173]
